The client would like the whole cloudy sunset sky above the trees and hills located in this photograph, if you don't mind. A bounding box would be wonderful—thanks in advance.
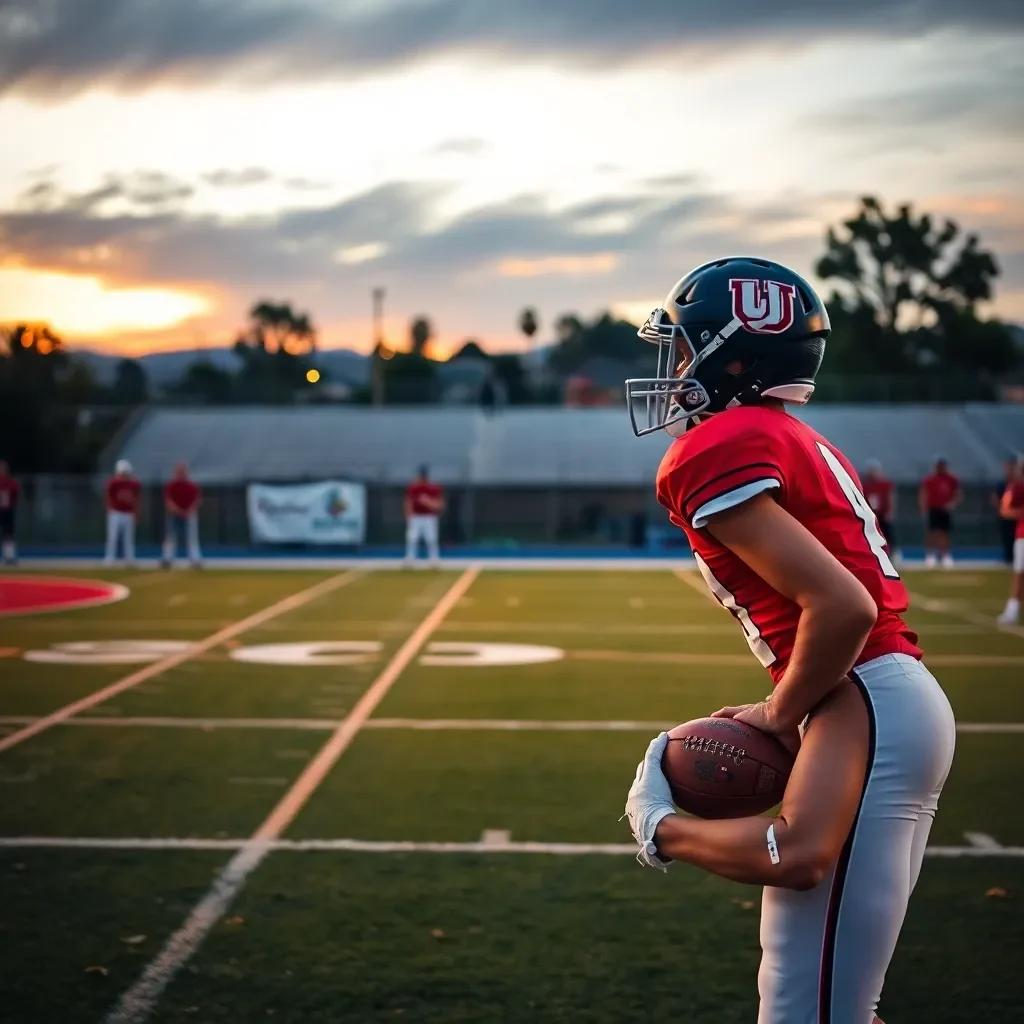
[0,0,1024,353]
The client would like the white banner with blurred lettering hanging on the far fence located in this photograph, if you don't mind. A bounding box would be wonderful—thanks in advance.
[247,480,367,544]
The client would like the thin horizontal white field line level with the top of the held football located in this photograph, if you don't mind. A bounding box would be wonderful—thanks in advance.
[0,715,1024,733]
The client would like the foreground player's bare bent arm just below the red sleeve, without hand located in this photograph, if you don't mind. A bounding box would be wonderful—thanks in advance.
[708,494,878,734]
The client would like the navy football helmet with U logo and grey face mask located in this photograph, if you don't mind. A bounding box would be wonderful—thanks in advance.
[626,256,830,437]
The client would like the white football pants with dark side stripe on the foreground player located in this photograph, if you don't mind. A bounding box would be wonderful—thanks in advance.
[758,654,956,1024]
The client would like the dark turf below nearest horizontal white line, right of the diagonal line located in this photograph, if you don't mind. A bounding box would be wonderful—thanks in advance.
[151,854,1024,1024]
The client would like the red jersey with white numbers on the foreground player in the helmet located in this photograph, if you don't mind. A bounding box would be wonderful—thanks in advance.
[657,406,922,683]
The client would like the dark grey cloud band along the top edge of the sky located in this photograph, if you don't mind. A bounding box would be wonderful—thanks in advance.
[0,0,1024,94]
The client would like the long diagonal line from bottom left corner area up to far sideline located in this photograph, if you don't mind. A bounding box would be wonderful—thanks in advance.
[104,567,479,1024]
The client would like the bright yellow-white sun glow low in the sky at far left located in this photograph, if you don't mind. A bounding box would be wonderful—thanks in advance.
[0,267,211,338]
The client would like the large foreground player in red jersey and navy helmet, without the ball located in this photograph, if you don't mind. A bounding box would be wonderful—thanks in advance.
[626,258,955,1024]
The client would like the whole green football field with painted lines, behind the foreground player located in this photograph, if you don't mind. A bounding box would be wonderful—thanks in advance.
[0,569,1024,1024]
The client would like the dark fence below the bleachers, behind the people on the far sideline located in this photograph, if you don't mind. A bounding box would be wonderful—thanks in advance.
[8,476,1011,552]
